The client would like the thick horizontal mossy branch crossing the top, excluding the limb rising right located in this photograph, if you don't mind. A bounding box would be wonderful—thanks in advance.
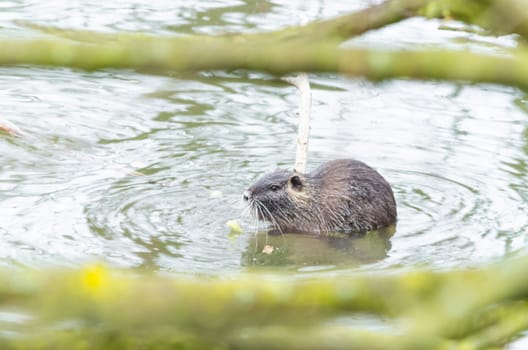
[0,38,528,88]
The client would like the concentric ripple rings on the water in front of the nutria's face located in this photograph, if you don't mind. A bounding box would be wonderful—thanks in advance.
[85,174,248,272]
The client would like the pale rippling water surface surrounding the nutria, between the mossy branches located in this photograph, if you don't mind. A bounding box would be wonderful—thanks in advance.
[0,0,528,275]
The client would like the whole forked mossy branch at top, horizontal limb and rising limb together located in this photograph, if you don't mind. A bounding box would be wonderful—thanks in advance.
[0,0,528,88]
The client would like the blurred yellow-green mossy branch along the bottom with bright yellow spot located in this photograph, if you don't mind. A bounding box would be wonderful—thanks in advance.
[0,256,528,349]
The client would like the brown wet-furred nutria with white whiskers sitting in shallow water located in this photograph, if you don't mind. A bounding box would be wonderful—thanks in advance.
[244,159,396,234]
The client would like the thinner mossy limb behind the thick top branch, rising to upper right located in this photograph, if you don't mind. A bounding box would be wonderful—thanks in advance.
[16,0,528,43]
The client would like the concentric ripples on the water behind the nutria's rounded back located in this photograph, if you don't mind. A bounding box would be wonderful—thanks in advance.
[391,171,486,264]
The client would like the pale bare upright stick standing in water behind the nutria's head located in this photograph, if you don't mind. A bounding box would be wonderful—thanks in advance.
[283,73,312,173]
